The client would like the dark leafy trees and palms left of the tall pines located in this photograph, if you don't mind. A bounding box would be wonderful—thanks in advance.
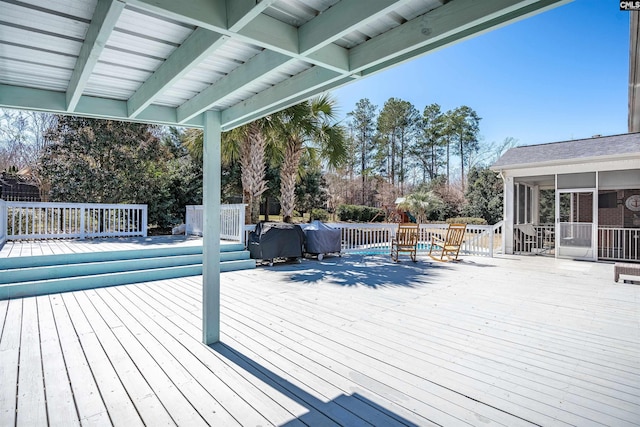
[0,96,347,227]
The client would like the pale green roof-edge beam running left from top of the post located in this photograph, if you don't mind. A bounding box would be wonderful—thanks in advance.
[0,84,202,127]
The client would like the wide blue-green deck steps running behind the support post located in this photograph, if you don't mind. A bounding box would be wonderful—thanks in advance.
[0,244,256,300]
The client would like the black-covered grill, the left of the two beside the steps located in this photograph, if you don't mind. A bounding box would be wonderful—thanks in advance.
[248,222,304,260]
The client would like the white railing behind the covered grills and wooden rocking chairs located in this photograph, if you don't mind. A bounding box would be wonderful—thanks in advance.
[245,222,503,257]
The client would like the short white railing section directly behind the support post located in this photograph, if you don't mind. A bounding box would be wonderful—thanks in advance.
[185,204,246,243]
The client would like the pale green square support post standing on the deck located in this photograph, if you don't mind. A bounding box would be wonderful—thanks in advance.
[202,111,222,344]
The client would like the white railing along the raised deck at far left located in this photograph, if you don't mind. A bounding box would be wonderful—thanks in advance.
[0,201,147,241]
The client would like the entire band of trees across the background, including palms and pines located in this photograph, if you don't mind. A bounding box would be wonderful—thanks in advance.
[0,96,515,231]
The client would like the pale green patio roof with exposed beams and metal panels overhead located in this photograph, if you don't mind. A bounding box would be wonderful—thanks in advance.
[0,0,568,130]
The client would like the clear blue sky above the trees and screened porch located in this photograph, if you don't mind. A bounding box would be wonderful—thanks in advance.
[332,0,629,145]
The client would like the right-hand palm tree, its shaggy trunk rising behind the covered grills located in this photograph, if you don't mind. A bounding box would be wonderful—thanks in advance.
[271,95,347,221]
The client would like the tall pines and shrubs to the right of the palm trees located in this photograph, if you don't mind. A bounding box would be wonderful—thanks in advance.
[327,98,517,222]
